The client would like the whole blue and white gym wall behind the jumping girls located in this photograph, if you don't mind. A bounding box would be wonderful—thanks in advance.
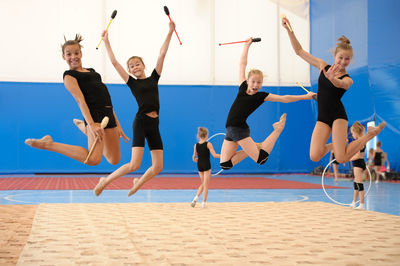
[0,0,400,173]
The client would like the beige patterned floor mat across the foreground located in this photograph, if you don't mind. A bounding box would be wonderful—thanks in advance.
[0,202,400,265]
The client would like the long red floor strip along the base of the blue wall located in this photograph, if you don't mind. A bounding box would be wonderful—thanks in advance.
[0,177,345,190]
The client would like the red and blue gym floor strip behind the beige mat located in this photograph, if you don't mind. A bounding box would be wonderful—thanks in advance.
[0,174,400,216]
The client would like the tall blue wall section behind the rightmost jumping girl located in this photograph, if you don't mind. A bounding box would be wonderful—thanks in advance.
[310,0,400,171]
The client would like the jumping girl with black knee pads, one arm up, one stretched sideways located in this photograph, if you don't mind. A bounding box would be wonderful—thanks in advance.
[220,38,315,170]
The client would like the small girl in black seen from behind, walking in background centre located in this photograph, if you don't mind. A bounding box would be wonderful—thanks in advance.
[191,127,220,208]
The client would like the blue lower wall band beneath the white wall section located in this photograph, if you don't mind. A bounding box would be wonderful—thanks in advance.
[0,82,314,173]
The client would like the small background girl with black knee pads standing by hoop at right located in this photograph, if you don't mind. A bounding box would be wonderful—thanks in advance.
[350,122,366,210]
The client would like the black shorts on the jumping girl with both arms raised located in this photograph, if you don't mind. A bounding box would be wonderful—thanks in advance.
[132,115,163,150]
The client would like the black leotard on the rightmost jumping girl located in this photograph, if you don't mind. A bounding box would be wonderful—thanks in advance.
[317,65,350,127]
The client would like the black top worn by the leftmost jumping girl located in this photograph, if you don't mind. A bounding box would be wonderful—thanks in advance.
[63,68,112,110]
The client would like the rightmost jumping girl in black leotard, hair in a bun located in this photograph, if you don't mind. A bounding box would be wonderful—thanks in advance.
[282,18,386,163]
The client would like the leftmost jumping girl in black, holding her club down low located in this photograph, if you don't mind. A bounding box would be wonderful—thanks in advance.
[25,35,129,165]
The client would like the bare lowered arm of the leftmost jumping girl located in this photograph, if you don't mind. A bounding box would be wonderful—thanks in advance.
[64,75,104,138]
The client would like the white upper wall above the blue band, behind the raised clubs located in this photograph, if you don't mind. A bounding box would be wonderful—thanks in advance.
[0,0,309,85]
